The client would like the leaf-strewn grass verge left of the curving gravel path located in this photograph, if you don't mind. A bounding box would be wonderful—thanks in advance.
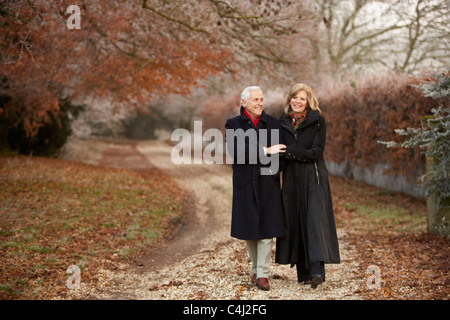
[0,156,183,299]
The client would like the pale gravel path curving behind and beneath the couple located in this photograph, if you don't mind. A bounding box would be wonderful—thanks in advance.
[63,141,365,300]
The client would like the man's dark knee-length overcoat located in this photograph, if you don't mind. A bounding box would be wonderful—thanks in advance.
[225,108,283,240]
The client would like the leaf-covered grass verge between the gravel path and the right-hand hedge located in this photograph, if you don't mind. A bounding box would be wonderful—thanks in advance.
[330,177,450,300]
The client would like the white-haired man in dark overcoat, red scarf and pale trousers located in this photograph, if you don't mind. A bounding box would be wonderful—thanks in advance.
[225,87,286,290]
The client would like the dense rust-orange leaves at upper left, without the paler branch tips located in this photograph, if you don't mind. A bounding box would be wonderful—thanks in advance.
[0,0,230,137]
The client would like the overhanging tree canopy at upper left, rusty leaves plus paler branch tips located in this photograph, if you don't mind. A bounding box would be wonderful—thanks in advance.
[0,0,312,142]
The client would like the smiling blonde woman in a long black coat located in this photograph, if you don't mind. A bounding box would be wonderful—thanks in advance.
[275,83,340,288]
